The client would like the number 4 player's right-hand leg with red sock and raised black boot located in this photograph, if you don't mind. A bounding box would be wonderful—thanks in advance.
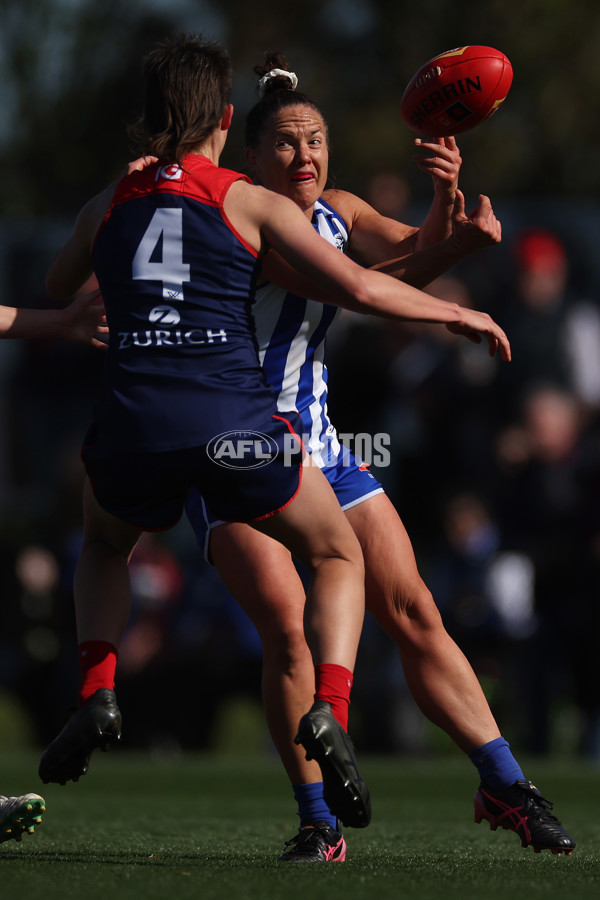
[258,457,371,828]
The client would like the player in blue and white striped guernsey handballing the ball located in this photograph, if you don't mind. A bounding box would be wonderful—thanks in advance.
[187,55,574,861]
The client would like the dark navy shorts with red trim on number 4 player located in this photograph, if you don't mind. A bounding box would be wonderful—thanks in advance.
[81,413,304,531]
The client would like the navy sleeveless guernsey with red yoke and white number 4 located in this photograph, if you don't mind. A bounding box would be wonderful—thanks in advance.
[92,154,276,452]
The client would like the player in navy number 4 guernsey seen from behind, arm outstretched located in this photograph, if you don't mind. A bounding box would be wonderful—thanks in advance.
[39,35,510,827]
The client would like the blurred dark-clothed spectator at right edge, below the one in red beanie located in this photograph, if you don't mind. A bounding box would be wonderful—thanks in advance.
[496,386,600,759]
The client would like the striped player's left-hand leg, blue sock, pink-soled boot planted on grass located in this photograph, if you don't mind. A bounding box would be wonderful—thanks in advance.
[210,523,346,862]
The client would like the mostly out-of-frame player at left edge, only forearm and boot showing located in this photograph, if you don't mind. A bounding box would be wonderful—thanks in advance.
[0,290,108,844]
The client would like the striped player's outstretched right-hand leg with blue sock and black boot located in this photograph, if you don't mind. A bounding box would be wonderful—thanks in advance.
[347,494,575,855]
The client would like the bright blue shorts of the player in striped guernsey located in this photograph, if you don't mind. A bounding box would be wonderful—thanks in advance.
[185,445,384,562]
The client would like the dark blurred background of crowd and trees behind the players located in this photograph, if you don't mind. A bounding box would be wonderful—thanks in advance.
[0,0,600,761]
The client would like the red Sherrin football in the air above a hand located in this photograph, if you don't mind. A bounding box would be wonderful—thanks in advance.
[400,46,512,137]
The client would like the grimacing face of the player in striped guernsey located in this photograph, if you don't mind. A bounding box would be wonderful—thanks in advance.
[246,106,329,213]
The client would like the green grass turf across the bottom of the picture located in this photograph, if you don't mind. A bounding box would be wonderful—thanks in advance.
[0,749,600,900]
